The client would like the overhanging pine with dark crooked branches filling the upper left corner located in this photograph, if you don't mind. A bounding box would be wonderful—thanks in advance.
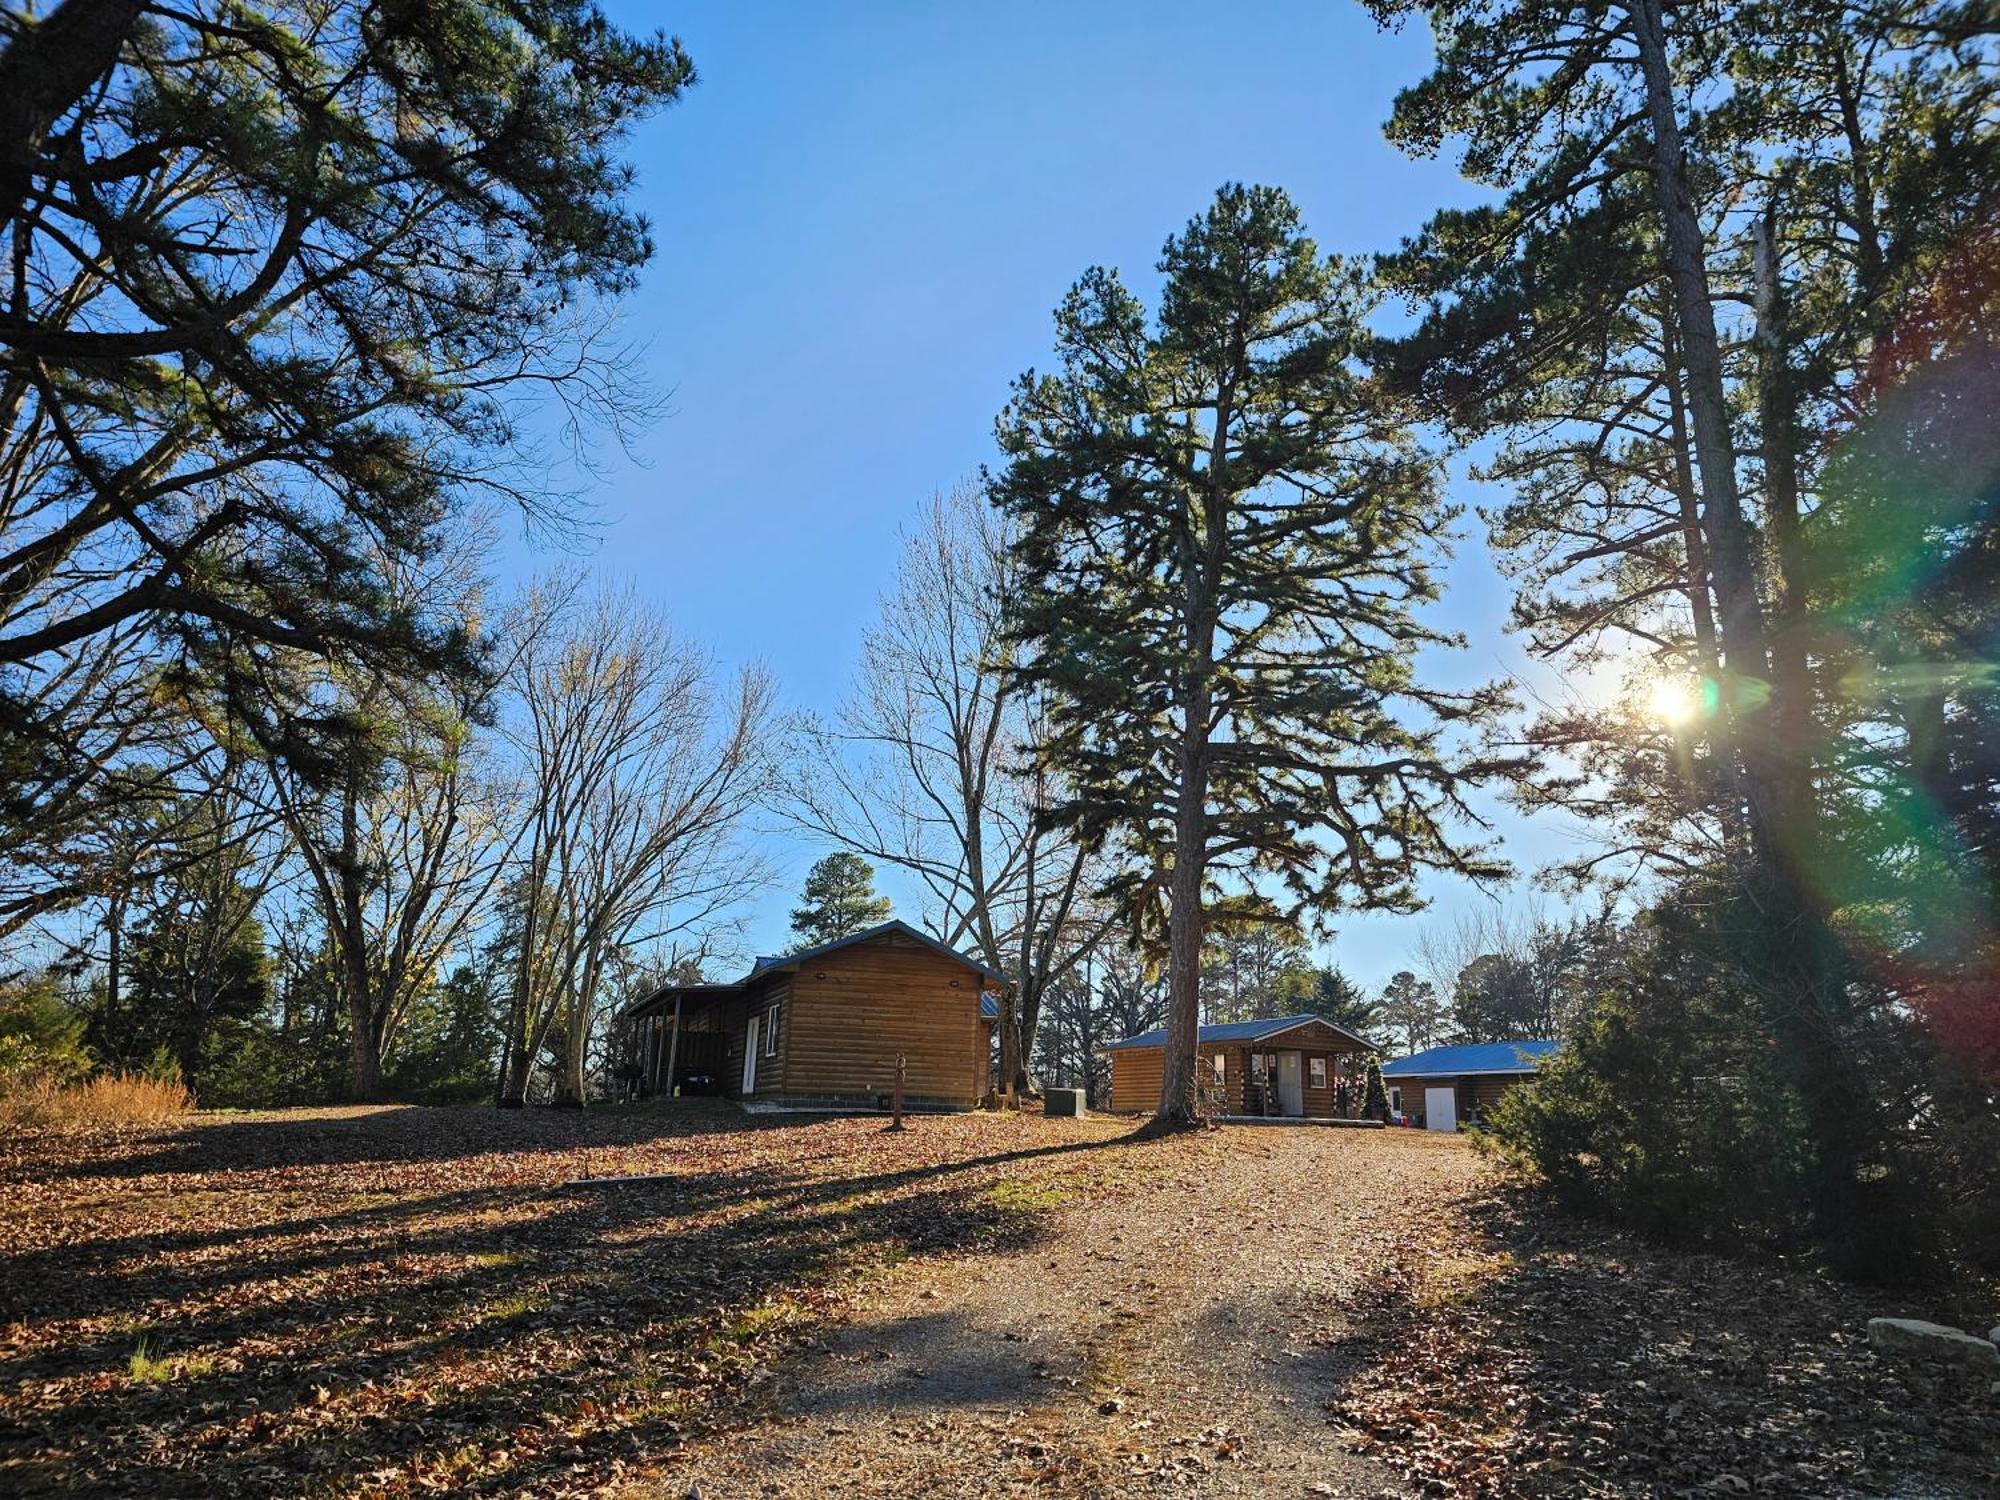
[0,0,694,930]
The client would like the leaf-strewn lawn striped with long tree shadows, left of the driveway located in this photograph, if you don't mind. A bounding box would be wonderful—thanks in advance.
[0,1110,1148,1496]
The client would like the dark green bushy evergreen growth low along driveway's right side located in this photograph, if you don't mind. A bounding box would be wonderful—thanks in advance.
[1482,888,2000,1296]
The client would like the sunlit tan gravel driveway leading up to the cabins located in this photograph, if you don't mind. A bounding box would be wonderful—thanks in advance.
[654,1126,1484,1500]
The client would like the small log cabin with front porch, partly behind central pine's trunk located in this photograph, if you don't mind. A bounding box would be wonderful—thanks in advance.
[1100,1016,1376,1120]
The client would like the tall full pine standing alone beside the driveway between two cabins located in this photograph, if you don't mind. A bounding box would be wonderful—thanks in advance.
[990,186,1500,1124]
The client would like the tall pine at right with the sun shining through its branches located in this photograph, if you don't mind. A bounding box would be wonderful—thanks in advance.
[1370,0,2000,1270]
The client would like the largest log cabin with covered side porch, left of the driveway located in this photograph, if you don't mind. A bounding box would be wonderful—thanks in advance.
[620,922,1000,1110]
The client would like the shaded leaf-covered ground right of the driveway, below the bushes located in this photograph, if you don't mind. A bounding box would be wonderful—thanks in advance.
[1328,1190,2000,1500]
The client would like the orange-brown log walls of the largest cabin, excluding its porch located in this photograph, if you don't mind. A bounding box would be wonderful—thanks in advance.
[768,938,988,1108]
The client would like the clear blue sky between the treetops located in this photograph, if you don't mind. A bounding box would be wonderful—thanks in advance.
[514,0,1592,1000]
